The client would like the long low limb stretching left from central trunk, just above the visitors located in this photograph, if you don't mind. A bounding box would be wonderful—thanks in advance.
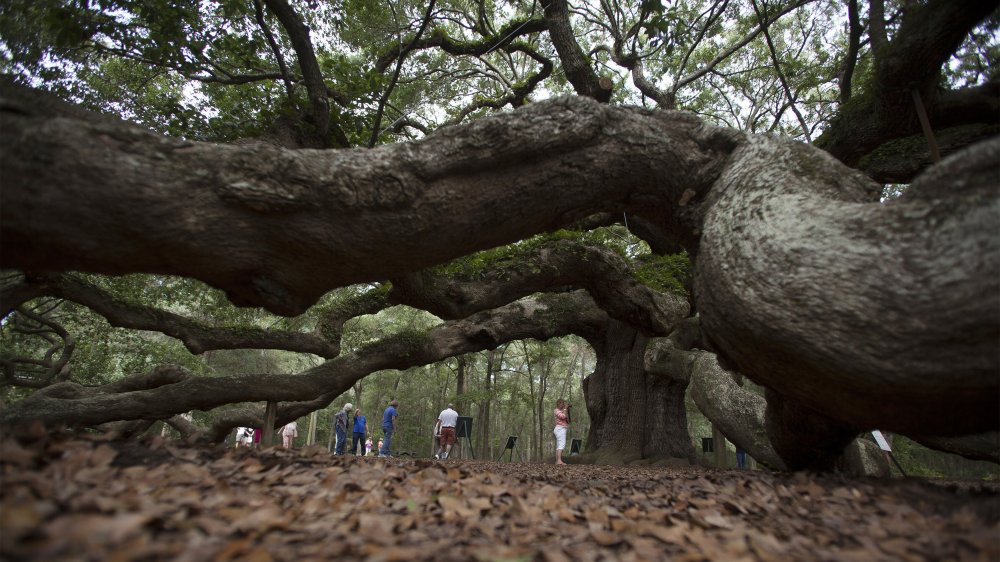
[0,292,608,425]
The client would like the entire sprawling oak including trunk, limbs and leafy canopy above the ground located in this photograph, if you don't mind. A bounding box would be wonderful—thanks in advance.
[0,0,1000,468]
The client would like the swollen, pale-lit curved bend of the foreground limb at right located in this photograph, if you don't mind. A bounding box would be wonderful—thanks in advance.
[695,133,1000,435]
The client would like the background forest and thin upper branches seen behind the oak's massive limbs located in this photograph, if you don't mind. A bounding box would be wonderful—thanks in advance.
[0,0,1000,478]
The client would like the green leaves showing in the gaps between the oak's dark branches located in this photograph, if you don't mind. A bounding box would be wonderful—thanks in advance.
[0,0,1000,460]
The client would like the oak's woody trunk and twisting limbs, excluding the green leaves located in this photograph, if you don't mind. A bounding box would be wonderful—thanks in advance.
[0,0,1000,468]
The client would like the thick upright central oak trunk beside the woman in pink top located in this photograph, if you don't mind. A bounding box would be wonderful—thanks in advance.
[580,320,694,464]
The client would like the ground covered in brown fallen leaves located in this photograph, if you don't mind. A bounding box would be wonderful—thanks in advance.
[0,426,1000,562]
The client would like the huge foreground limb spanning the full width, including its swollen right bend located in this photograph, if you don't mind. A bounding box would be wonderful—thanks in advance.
[0,80,1000,442]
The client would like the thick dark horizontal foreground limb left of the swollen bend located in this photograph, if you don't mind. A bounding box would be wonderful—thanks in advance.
[0,80,741,314]
